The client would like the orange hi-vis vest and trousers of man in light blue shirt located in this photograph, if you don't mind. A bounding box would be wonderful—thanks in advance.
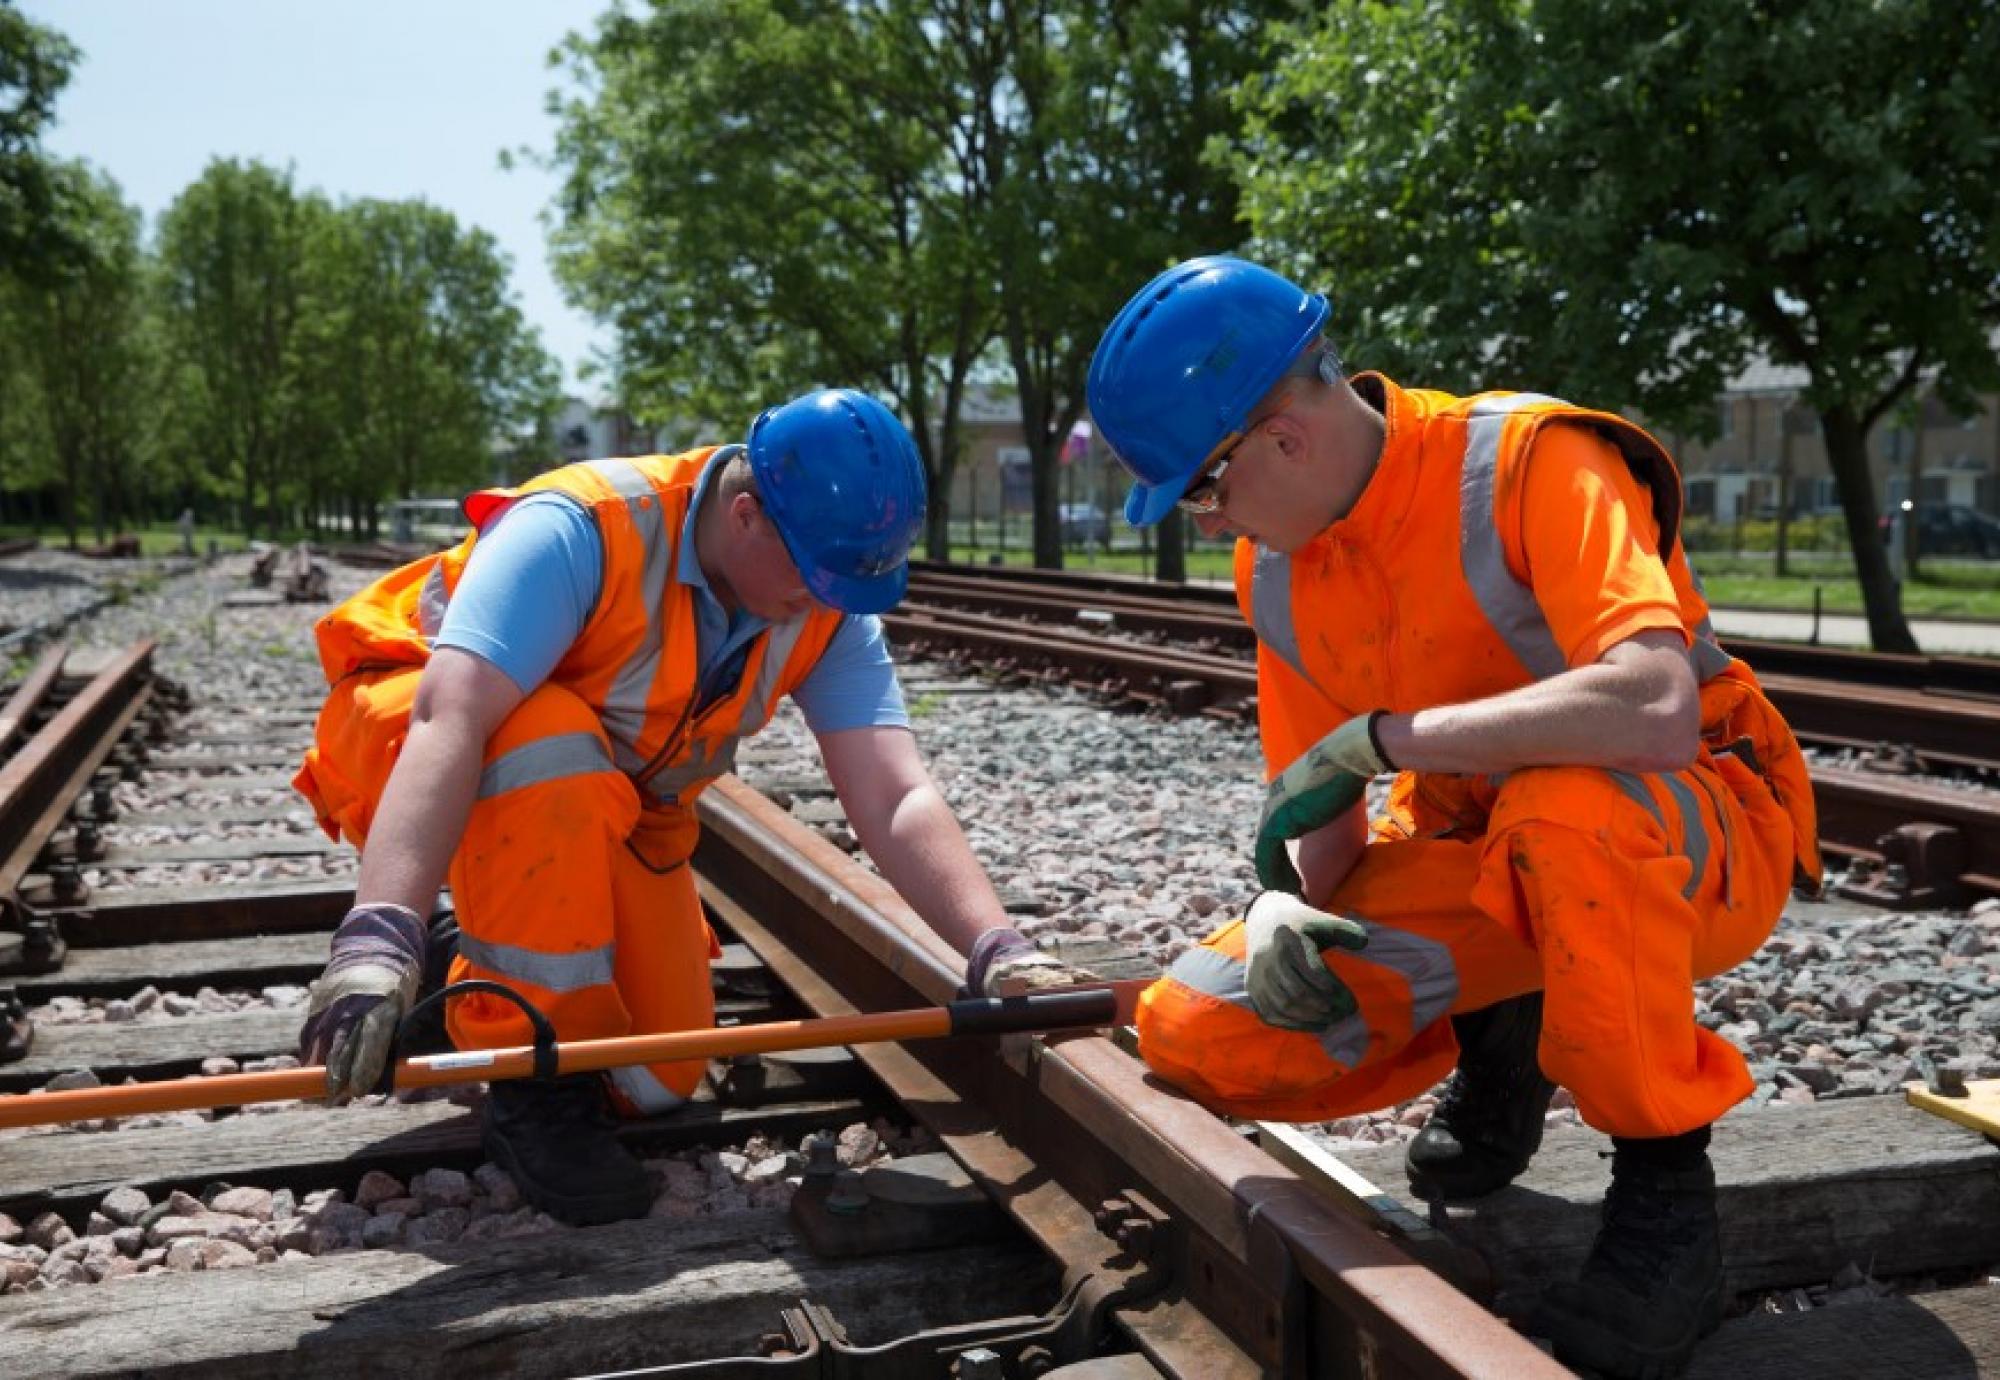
[294,448,840,1112]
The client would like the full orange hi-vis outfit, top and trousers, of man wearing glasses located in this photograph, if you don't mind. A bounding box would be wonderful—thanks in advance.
[1138,374,1820,1136]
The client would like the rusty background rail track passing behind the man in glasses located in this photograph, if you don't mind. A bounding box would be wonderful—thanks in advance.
[904,562,2000,908]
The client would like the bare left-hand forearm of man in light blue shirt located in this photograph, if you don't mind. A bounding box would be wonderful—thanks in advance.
[354,720,484,916]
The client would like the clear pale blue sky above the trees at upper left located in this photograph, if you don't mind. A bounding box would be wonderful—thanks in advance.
[18,0,604,390]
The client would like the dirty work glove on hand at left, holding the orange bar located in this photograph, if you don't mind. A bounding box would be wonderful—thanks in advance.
[298,902,424,1106]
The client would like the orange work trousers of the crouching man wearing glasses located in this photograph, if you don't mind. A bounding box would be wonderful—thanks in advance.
[1138,752,1794,1136]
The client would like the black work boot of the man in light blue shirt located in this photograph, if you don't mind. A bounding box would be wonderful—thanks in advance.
[480,1074,652,1226]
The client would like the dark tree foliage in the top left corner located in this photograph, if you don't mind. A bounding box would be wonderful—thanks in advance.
[0,0,76,272]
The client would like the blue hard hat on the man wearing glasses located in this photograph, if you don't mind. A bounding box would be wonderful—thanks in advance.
[1086,254,1330,528]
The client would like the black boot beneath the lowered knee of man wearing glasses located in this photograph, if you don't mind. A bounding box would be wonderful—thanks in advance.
[1404,992,1556,1202]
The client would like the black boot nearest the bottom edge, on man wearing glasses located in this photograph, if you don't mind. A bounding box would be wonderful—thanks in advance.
[1528,1126,1724,1380]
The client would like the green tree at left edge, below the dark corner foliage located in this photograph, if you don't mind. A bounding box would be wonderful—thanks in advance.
[0,164,148,550]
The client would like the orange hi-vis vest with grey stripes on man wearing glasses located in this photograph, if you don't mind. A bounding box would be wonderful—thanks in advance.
[1236,374,1820,884]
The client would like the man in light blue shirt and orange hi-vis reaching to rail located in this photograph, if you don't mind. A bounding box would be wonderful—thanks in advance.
[296,390,1090,1222]
